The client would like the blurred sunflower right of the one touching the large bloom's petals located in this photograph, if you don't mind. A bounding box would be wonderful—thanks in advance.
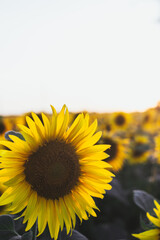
[128,135,151,164]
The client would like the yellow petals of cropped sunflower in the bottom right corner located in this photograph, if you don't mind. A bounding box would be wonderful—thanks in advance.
[132,200,160,240]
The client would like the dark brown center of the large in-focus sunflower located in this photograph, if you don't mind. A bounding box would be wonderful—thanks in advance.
[24,140,80,200]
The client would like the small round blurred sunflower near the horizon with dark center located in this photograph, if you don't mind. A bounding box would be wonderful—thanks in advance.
[112,112,131,130]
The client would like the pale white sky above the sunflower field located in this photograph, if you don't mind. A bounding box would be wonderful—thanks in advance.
[0,0,160,115]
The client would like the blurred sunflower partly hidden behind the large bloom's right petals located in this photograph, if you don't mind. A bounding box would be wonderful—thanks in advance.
[102,132,126,172]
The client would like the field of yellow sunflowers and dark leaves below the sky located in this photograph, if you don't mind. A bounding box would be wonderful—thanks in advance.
[0,105,160,240]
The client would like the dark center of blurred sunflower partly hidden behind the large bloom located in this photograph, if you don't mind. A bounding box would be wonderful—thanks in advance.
[103,138,118,162]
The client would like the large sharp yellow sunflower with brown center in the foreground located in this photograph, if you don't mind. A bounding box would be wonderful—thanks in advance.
[0,105,114,240]
